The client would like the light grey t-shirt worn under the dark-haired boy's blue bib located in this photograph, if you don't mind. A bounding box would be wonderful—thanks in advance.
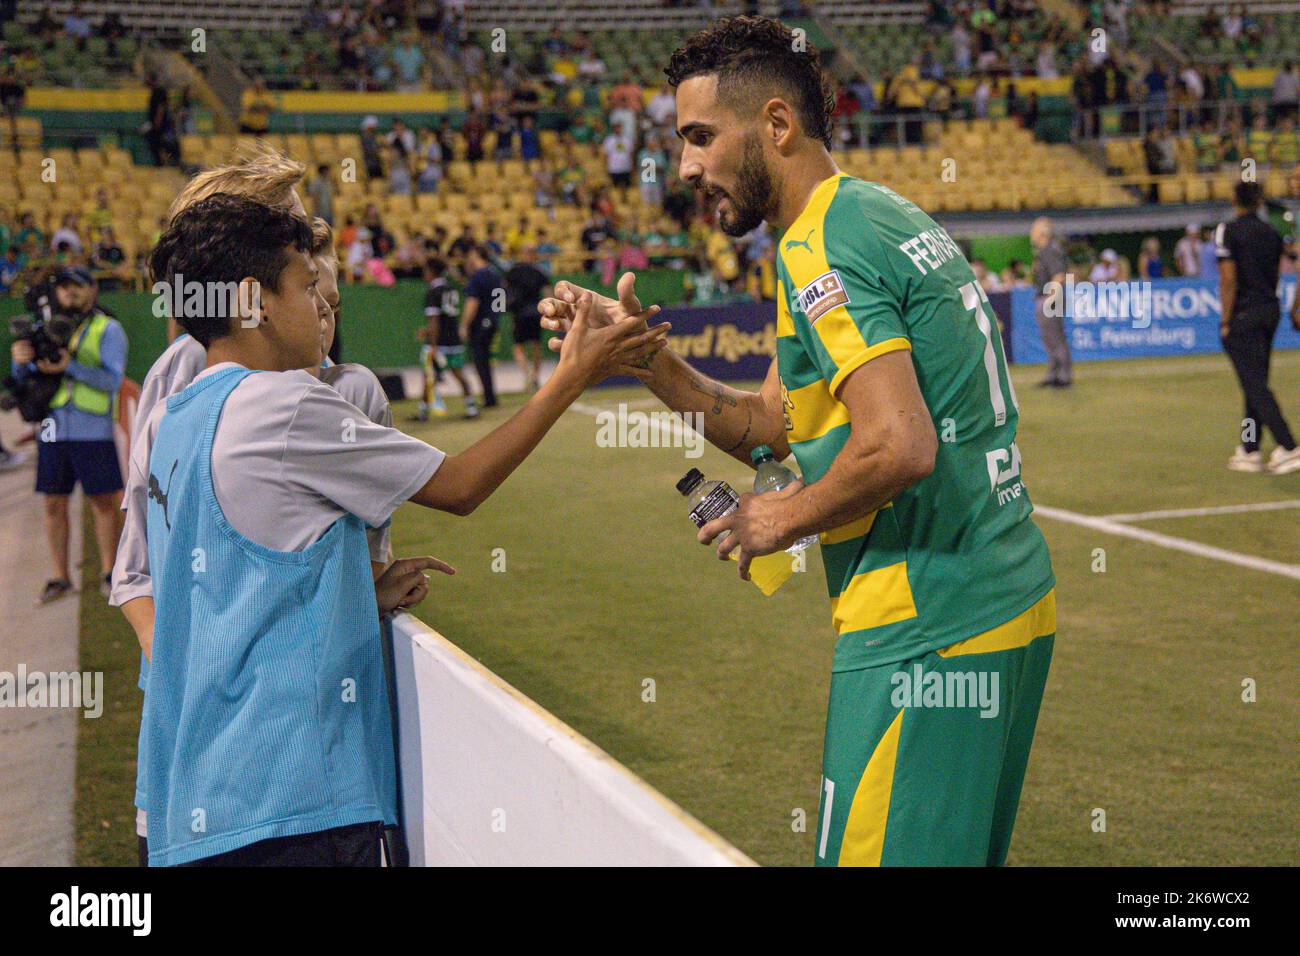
[111,362,445,606]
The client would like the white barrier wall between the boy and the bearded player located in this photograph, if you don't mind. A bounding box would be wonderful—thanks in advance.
[393,614,754,866]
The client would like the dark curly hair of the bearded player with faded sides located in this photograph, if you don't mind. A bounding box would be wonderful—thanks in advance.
[664,17,835,150]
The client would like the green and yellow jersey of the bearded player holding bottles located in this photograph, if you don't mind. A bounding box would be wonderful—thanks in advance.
[776,174,1054,671]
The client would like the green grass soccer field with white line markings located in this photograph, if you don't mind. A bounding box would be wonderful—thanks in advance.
[78,352,1300,865]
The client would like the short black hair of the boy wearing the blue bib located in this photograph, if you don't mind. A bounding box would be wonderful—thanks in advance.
[150,193,312,349]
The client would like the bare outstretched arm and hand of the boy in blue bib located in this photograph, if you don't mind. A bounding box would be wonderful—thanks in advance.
[411,295,670,515]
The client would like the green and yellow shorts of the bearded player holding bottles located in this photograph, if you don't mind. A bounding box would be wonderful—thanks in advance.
[814,591,1056,866]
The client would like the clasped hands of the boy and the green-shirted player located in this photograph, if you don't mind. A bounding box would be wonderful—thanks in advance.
[538,272,672,388]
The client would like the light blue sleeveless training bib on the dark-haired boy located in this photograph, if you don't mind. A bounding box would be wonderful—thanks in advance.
[140,368,397,866]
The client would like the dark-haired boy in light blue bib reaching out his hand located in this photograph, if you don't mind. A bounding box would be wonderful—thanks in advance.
[124,194,667,865]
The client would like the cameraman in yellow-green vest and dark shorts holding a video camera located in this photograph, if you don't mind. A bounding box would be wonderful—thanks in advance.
[12,267,126,604]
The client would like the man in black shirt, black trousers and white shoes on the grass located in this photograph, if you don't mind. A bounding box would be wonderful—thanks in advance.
[1214,182,1300,475]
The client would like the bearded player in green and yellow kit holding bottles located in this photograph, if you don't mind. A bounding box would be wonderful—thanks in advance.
[541,17,1056,865]
